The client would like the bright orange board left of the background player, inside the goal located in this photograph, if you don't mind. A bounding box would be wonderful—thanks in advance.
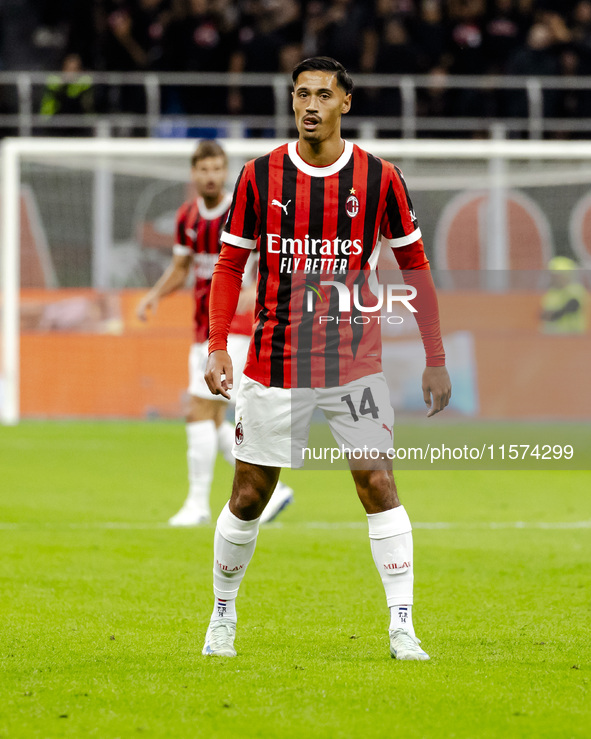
[21,290,193,418]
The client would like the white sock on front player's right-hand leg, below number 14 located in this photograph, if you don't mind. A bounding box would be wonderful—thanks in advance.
[367,506,414,634]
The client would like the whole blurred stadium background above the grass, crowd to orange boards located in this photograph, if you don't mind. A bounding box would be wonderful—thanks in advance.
[0,0,591,422]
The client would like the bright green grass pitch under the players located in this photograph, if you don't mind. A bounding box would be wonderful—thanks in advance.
[0,423,591,739]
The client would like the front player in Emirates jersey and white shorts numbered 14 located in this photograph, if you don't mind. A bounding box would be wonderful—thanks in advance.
[203,57,451,660]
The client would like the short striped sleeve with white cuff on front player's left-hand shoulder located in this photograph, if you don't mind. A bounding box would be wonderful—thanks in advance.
[221,162,261,249]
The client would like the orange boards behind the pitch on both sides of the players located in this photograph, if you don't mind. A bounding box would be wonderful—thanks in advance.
[21,290,591,419]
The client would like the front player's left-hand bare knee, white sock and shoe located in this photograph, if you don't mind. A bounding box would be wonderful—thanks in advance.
[203,459,280,657]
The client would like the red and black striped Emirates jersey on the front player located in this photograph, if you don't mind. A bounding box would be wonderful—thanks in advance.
[222,142,428,387]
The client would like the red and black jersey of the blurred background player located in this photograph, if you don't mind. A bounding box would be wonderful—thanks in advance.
[173,193,252,344]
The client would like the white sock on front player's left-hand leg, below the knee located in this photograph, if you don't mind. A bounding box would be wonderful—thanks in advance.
[213,503,260,618]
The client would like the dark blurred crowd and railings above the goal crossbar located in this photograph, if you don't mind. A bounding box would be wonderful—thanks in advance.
[0,0,591,138]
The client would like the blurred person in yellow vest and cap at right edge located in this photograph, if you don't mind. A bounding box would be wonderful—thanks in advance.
[540,257,588,334]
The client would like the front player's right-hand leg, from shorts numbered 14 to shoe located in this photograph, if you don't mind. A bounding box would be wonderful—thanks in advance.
[321,373,429,660]
